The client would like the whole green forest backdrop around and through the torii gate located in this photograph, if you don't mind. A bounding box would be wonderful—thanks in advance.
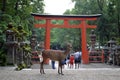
[0,0,120,48]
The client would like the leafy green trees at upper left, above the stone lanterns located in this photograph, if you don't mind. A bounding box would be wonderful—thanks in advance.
[0,0,44,41]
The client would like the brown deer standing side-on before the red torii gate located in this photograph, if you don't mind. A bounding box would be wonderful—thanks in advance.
[38,44,72,75]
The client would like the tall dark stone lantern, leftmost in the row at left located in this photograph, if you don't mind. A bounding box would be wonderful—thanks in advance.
[5,23,17,64]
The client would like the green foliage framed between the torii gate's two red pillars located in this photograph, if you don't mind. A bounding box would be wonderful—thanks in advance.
[51,28,81,47]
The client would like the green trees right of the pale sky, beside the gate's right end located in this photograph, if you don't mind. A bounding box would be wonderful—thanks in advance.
[65,0,120,45]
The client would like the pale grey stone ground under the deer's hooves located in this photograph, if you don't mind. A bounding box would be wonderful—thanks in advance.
[0,63,120,80]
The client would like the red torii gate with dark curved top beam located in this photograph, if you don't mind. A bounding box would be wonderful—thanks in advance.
[31,13,101,64]
